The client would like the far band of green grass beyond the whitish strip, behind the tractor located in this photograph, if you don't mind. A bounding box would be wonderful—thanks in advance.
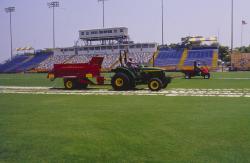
[0,72,250,88]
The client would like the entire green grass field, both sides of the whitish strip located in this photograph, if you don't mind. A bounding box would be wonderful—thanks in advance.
[0,72,250,163]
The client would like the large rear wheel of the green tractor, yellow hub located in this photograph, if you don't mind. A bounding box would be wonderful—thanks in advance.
[111,73,130,91]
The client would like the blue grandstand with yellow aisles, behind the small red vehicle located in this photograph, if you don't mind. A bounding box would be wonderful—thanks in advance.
[154,36,218,71]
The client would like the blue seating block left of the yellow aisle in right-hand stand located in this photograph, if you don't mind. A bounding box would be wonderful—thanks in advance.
[155,49,183,67]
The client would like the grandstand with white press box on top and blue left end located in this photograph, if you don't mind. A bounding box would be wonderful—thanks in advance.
[0,27,157,73]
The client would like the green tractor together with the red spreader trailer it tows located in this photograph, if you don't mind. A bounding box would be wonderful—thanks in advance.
[48,51,171,91]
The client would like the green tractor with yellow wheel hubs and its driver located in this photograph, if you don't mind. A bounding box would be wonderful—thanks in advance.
[111,51,171,91]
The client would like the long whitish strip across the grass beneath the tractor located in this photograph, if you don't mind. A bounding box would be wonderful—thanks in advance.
[0,86,250,98]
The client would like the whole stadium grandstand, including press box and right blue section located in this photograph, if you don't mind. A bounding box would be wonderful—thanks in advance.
[0,27,218,73]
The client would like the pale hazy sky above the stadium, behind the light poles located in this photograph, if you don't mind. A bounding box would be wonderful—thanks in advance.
[0,0,250,63]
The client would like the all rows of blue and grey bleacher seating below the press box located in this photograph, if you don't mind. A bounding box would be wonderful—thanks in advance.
[0,48,216,73]
